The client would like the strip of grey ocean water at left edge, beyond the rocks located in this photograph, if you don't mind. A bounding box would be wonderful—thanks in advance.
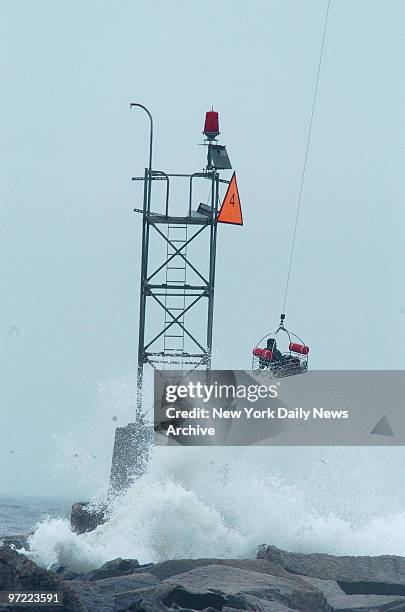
[0,495,71,538]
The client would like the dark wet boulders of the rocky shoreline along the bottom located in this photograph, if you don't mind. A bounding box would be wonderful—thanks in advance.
[0,539,405,612]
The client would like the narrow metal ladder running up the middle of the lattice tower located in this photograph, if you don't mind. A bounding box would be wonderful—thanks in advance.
[163,225,187,356]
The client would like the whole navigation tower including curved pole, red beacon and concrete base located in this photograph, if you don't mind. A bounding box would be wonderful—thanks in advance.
[110,104,231,492]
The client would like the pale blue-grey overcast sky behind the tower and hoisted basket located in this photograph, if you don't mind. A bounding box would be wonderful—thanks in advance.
[0,0,405,495]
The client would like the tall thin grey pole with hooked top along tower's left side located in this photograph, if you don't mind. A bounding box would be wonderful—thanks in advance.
[129,102,153,420]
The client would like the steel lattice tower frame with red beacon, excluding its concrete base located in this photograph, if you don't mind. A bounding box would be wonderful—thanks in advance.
[133,105,231,416]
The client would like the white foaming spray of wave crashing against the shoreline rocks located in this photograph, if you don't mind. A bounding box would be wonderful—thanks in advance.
[30,447,405,571]
